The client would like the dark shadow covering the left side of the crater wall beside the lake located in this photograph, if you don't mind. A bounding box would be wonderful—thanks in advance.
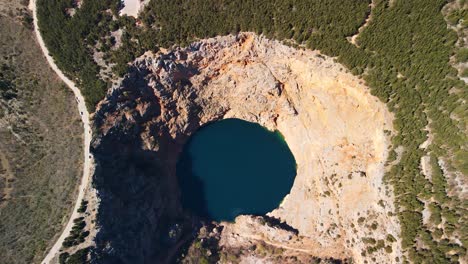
[91,59,205,264]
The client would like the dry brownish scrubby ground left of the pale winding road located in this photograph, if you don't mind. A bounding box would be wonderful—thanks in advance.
[0,0,83,263]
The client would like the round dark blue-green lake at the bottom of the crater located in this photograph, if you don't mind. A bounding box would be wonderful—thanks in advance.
[177,119,296,221]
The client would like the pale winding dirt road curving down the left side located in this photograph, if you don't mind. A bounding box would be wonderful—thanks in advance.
[29,0,93,264]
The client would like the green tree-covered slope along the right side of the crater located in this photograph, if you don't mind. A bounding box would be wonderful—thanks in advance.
[358,1,468,263]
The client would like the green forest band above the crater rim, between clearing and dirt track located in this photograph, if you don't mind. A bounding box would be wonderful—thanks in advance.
[123,0,370,73]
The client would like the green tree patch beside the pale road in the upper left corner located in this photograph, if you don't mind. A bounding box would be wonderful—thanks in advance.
[37,0,119,110]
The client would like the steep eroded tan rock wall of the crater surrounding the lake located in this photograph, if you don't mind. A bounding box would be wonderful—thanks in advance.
[93,33,401,263]
